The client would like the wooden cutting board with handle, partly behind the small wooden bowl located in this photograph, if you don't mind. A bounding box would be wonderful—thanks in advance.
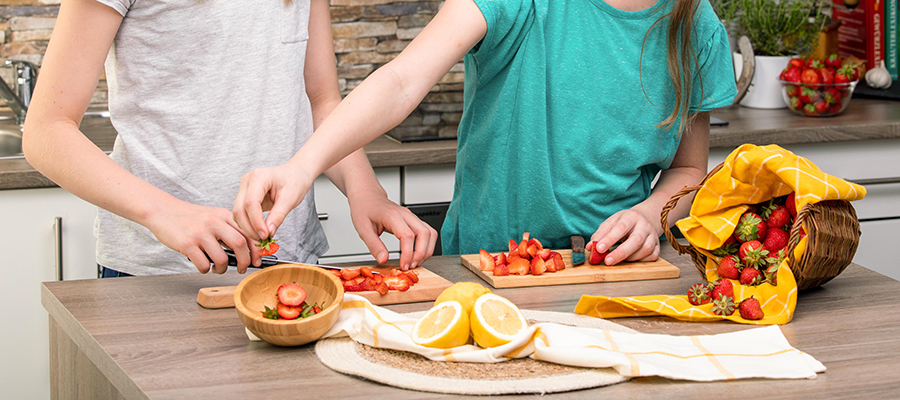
[197,265,452,308]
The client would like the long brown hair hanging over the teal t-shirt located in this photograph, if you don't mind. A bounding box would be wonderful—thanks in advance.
[638,0,703,134]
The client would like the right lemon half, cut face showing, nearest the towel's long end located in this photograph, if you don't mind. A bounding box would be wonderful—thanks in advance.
[470,293,528,348]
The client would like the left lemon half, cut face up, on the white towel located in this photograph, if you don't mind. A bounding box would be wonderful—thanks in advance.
[410,300,469,349]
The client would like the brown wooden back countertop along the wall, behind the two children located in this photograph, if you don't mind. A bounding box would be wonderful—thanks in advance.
[0,99,900,190]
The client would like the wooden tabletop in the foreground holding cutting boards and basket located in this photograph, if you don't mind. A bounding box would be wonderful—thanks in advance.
[41,244,900,400]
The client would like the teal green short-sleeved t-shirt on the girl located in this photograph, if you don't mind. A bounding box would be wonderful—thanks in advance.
[441,0,736,254]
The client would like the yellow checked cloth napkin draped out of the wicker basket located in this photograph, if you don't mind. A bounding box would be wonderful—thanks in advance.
[575,144,866,325]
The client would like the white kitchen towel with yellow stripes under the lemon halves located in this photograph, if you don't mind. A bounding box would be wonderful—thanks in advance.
[247,293,825,381]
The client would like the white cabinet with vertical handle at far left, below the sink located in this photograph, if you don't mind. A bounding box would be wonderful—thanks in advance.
[0,188,97,399]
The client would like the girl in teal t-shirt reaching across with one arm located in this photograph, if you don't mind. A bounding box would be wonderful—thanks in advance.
[235,0,736,264]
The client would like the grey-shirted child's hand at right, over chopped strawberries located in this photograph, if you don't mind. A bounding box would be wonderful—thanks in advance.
[347,193,437,271]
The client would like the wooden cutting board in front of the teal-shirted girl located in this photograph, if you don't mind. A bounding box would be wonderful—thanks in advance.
[460,250,681,289]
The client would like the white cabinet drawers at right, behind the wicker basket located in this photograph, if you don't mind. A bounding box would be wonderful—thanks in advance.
[709,139,900,279]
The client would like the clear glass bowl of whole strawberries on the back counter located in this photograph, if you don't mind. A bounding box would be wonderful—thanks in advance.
[779,54,860,117]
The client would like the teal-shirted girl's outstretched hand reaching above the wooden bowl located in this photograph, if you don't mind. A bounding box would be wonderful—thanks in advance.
[234,164,315,241]
